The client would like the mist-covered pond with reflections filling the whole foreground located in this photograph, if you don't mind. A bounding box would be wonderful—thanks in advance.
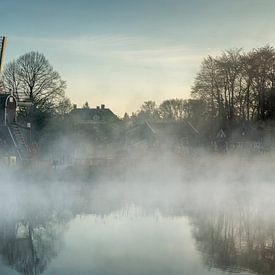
[0,152,275,275]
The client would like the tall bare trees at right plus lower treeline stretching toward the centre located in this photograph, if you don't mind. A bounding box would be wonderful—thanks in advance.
[129,46,275,127]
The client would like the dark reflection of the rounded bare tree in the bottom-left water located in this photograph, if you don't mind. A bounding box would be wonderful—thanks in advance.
[0,215,69,275]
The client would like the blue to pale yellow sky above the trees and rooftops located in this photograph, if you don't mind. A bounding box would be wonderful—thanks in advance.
[0,0,275,116]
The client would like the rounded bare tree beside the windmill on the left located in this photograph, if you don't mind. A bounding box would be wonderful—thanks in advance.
[3,52,66,111]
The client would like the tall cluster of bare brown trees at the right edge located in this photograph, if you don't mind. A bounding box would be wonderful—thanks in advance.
[192,46,275,121]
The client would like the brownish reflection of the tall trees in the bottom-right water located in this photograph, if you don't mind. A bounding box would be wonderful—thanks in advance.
[191,205,275,274]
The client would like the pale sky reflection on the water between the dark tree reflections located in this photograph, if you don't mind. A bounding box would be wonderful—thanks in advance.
[46,205,221,275]
